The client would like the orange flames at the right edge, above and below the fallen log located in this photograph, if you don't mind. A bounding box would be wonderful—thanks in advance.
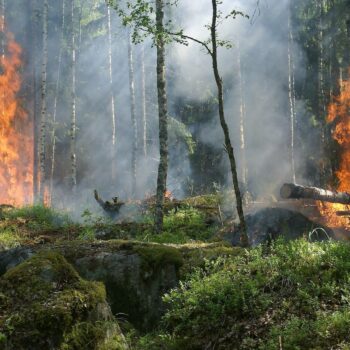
[318,69,350,230]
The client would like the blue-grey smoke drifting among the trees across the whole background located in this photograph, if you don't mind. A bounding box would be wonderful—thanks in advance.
[4,0,312,215]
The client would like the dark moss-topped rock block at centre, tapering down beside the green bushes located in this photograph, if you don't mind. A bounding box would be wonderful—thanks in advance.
[56,241,183,330]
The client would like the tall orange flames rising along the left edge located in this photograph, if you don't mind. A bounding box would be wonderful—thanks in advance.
[0,23,33,205]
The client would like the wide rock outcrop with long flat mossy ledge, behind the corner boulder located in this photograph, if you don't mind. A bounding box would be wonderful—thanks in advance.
[0,241,241,331]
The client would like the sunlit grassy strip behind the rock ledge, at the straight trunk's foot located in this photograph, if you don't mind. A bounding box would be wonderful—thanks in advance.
[0,195,218,250]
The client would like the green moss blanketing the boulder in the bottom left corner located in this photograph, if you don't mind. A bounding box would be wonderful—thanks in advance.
[0,252,125,349]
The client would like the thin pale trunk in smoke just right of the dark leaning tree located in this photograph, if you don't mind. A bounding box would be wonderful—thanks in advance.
[237,42,248,189]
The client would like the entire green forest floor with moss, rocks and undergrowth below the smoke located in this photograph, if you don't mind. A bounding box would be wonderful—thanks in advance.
[0,200,350,350]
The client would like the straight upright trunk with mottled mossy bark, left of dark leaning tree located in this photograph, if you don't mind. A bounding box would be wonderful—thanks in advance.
[155,0,168,233]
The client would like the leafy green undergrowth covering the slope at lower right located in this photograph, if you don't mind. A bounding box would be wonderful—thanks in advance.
[135,240,350,350]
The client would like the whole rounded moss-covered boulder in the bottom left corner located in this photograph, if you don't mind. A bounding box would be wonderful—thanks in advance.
[0,251,127,350]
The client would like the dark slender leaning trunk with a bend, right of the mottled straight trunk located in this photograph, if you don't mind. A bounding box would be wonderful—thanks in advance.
[211,0,249,246]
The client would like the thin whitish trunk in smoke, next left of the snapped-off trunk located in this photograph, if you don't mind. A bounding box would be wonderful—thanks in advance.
[107,6,117,182]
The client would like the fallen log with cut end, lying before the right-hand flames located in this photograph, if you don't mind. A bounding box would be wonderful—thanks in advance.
[280,183,350,204]
